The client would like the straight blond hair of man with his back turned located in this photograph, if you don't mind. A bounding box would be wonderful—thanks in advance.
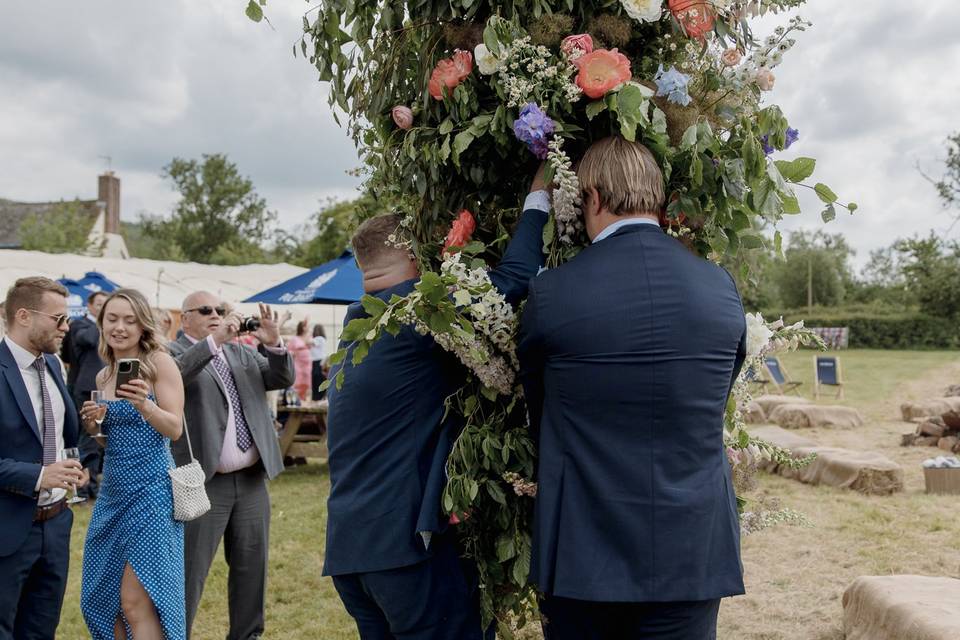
[577,136,665,216]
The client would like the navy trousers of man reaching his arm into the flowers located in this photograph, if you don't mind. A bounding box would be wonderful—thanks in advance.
[333,535,493,640]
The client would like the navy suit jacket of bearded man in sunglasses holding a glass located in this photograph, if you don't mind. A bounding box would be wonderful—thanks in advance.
[0,340,79,557]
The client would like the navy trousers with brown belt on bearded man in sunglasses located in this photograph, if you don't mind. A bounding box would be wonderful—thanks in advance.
[0,509,73,640]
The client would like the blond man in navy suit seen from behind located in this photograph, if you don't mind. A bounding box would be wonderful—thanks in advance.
[518,137,746,640]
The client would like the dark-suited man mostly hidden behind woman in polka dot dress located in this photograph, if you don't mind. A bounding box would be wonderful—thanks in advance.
[60,291,107,498]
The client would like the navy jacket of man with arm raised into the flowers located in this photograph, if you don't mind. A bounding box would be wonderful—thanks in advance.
[323,210,547,575]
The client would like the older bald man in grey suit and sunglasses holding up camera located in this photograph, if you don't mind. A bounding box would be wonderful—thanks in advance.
[170,291,294,640]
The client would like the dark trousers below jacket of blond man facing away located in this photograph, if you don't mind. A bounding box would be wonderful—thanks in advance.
[540,596,720,640]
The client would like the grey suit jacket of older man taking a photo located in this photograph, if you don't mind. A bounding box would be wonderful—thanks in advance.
[168,336,294,480]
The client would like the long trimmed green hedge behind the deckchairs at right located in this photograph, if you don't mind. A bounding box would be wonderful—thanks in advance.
[764,309,960,349]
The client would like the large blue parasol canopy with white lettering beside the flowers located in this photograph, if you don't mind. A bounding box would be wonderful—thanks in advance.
[244,251,363,304]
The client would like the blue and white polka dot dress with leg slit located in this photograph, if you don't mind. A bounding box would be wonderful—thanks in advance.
[80,400,186,640]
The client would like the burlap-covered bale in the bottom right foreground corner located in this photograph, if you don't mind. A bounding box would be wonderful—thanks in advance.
[843,576,960,640]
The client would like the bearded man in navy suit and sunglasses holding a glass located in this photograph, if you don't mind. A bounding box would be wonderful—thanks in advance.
[0,277,87,640]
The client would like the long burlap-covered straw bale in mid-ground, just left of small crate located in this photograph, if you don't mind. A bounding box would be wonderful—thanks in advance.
[751,427,903,495]
